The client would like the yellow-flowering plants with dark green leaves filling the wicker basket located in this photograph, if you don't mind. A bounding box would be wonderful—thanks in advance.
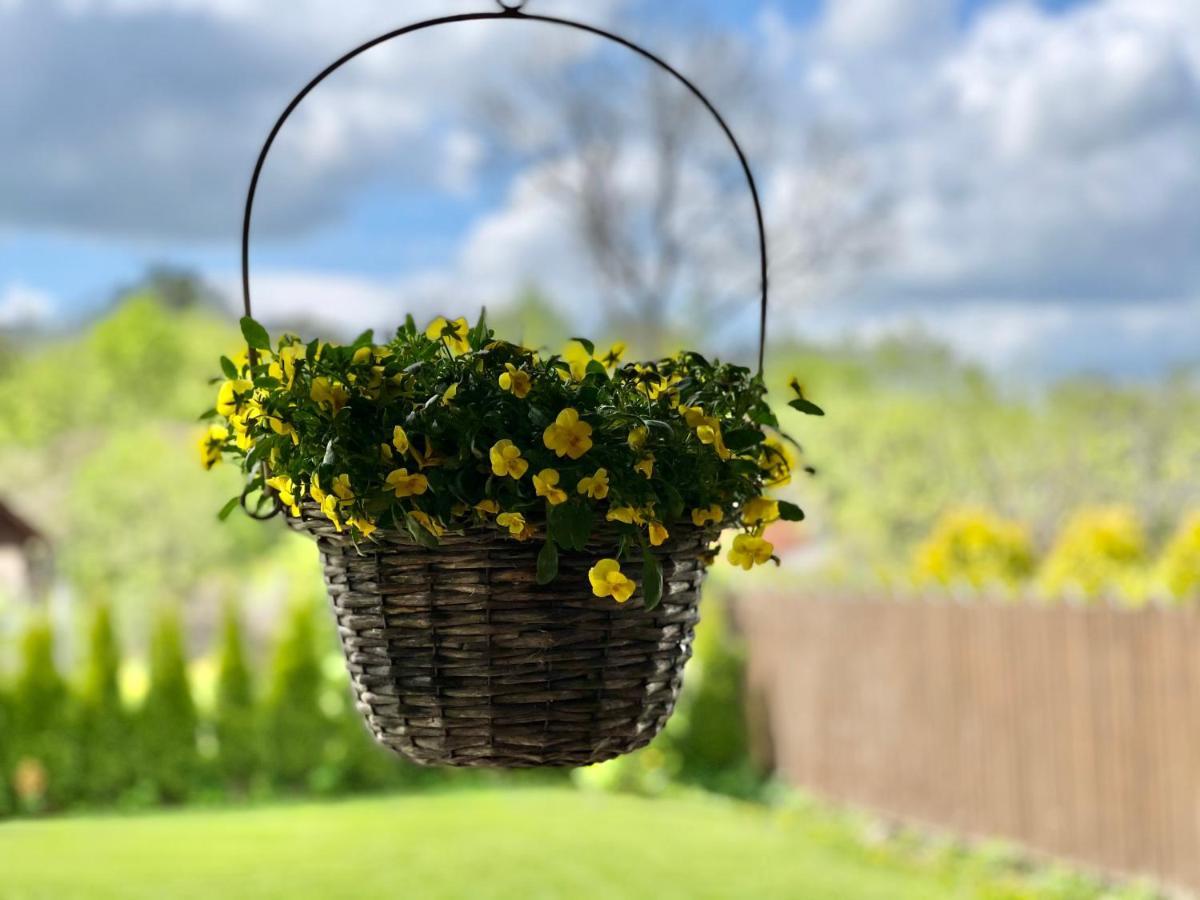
[199,318,821,605]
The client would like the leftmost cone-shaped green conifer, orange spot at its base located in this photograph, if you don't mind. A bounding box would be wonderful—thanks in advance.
[7,619,78,811]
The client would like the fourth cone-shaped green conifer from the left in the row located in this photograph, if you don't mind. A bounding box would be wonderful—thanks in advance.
[214,604,260,792]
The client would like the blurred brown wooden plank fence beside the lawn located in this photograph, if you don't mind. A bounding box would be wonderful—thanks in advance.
[738,596,1200,890]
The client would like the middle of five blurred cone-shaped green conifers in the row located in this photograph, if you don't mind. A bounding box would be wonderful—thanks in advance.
[138,611,199,803]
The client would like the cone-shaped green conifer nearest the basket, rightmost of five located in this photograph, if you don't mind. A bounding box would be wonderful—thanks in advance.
[263,602,329,788]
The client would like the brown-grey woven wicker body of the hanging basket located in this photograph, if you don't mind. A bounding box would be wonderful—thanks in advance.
[289,503,716,768]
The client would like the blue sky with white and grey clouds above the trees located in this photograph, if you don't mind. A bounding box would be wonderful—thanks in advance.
[0,0,1200,376]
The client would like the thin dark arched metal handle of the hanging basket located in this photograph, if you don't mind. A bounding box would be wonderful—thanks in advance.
[241,0,767,374]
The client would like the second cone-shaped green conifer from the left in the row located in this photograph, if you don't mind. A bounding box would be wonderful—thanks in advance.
[79,602,134,803]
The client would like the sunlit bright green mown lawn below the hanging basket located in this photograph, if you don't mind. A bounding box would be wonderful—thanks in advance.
[0,788,962,900]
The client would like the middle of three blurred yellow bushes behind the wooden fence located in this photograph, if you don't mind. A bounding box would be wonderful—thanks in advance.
[1038,506,1146,600]
